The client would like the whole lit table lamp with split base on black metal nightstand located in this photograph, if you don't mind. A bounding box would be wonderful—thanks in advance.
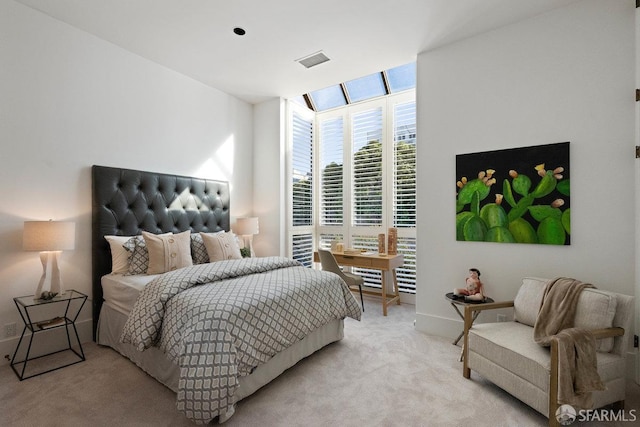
[22,220,76,299]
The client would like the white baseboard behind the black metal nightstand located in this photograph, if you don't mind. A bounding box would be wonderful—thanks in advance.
[0,319,93,365]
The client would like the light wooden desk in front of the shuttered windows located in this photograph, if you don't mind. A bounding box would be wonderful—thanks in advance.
[313,251,404,316]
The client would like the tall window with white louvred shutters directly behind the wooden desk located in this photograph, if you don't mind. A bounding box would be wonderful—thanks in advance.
[314,92,416,292]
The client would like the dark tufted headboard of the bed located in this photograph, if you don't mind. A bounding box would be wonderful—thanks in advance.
[91,165,230,340]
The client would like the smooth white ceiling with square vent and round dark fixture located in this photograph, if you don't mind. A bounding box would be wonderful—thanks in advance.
[16,0,577,103]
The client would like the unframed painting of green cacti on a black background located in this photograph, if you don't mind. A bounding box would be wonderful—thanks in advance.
[456,142,571,245]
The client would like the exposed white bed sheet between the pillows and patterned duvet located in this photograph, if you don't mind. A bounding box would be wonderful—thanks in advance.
[101,273,159,315]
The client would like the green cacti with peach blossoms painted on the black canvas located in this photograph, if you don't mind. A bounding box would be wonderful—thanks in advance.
[456,164,571,245]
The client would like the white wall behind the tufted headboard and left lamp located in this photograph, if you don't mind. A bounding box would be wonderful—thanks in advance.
[0,1,254,356]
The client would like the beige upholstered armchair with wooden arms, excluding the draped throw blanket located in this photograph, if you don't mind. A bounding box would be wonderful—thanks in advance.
[463,278,634,426]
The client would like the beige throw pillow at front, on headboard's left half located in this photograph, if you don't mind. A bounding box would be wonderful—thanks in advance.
[142,230,193,274]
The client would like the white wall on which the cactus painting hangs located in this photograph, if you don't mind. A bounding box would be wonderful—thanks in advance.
[416,0,636,356]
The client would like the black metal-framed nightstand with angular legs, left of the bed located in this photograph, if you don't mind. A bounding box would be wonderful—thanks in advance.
[11,289,87,381]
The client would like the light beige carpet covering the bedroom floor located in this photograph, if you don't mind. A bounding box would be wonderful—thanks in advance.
[0,299,640,427]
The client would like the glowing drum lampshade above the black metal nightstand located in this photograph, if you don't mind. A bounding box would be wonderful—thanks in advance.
[22,221,76,251]
